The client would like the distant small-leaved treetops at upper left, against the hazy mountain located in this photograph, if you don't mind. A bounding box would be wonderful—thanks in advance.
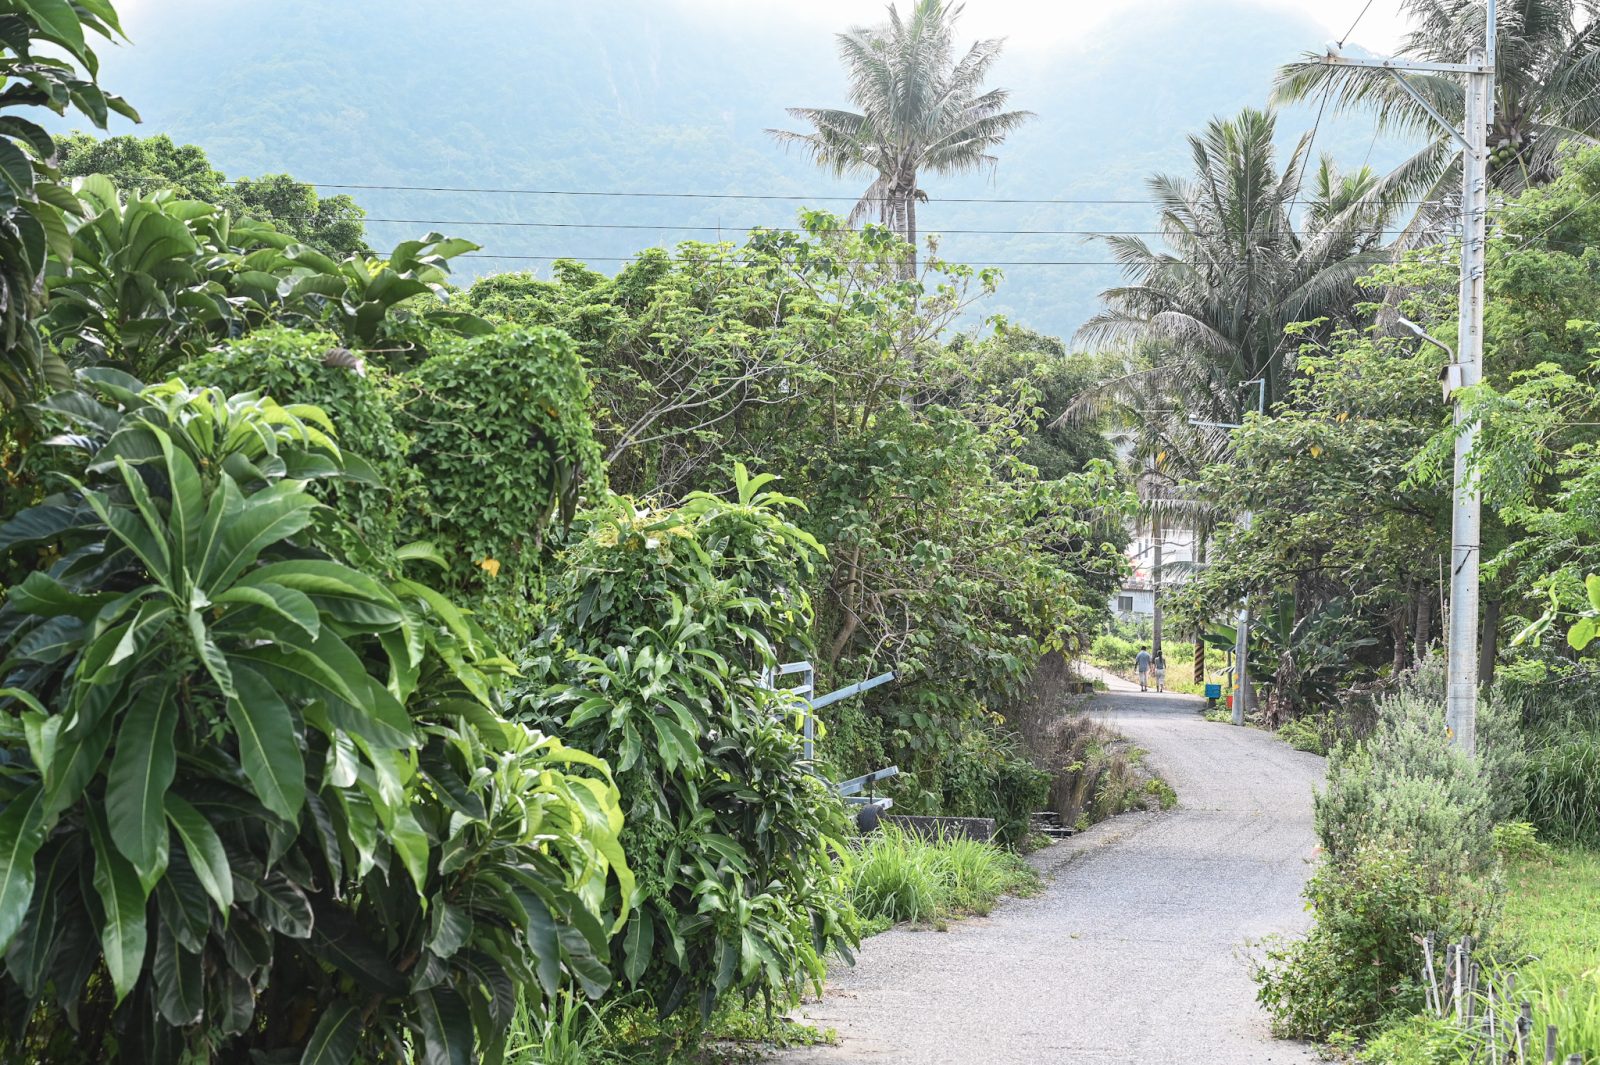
[56,133,368,257]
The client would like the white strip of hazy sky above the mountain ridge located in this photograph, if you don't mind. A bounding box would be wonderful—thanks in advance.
[668,0,1405,53]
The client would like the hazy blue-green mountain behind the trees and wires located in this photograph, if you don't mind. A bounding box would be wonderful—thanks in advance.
[75,0,1398,334]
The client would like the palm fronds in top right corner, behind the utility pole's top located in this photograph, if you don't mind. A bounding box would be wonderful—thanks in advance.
[1274,0,1600,228]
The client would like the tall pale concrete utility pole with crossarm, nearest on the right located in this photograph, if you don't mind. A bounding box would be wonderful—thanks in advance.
[1322,0,1496,753]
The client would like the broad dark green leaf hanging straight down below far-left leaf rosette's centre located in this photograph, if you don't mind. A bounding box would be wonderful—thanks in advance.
[106,678,178,880]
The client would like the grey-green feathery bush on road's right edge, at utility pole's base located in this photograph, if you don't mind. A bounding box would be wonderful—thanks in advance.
[1256,676,1522,1039]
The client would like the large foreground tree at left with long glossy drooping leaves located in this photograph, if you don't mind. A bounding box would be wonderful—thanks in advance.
[0,368,634,1065]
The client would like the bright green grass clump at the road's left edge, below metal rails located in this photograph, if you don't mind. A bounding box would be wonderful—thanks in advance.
[850,825,1040,934]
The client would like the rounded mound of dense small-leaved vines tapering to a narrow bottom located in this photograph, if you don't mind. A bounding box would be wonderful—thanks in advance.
[398,328,605,640]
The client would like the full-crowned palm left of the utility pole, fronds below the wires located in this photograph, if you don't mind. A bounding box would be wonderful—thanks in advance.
[1078,109,1390,422]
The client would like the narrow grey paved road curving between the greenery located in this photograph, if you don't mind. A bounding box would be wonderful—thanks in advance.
[778,681,1323,1065]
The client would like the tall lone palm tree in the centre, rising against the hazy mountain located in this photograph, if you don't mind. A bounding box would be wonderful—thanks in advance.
[768,0,1032,267]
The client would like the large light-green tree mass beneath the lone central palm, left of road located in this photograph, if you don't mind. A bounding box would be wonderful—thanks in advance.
[467,214,1128,812]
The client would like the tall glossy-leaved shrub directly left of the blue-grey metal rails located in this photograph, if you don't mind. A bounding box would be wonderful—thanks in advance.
[522,467,854,1019]
